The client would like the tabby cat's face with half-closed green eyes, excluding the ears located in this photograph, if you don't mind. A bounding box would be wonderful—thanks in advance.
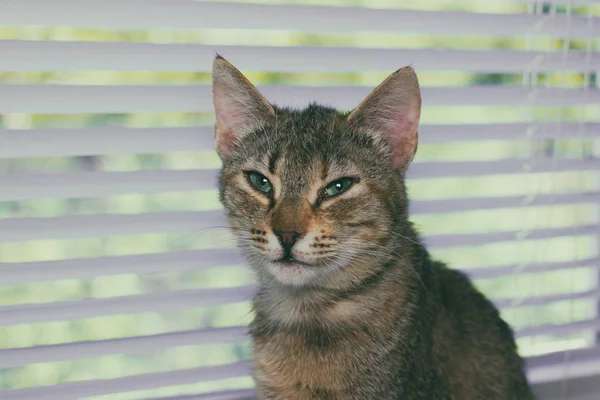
[221,107,398,285]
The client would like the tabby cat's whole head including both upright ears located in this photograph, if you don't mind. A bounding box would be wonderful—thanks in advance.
[213,57,421,288]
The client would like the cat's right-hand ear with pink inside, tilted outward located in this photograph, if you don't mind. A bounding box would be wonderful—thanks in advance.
[348,67,421,170]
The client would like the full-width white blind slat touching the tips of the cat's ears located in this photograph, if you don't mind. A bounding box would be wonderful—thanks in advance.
[0,40,600,74]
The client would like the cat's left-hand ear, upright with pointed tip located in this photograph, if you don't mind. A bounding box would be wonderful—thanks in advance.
[212,56,275,158]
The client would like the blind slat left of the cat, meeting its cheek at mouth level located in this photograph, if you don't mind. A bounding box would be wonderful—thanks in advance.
[0,249,246,286]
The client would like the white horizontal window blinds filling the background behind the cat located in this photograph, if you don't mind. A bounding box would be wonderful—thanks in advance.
[0,0,600,400]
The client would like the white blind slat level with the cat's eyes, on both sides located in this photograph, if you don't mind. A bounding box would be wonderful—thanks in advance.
[0,158,600,202]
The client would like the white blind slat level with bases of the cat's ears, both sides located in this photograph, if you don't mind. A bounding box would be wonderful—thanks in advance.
[0,122,600,159]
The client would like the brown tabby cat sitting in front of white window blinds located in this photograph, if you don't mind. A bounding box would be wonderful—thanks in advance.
[213,56,534,400]
